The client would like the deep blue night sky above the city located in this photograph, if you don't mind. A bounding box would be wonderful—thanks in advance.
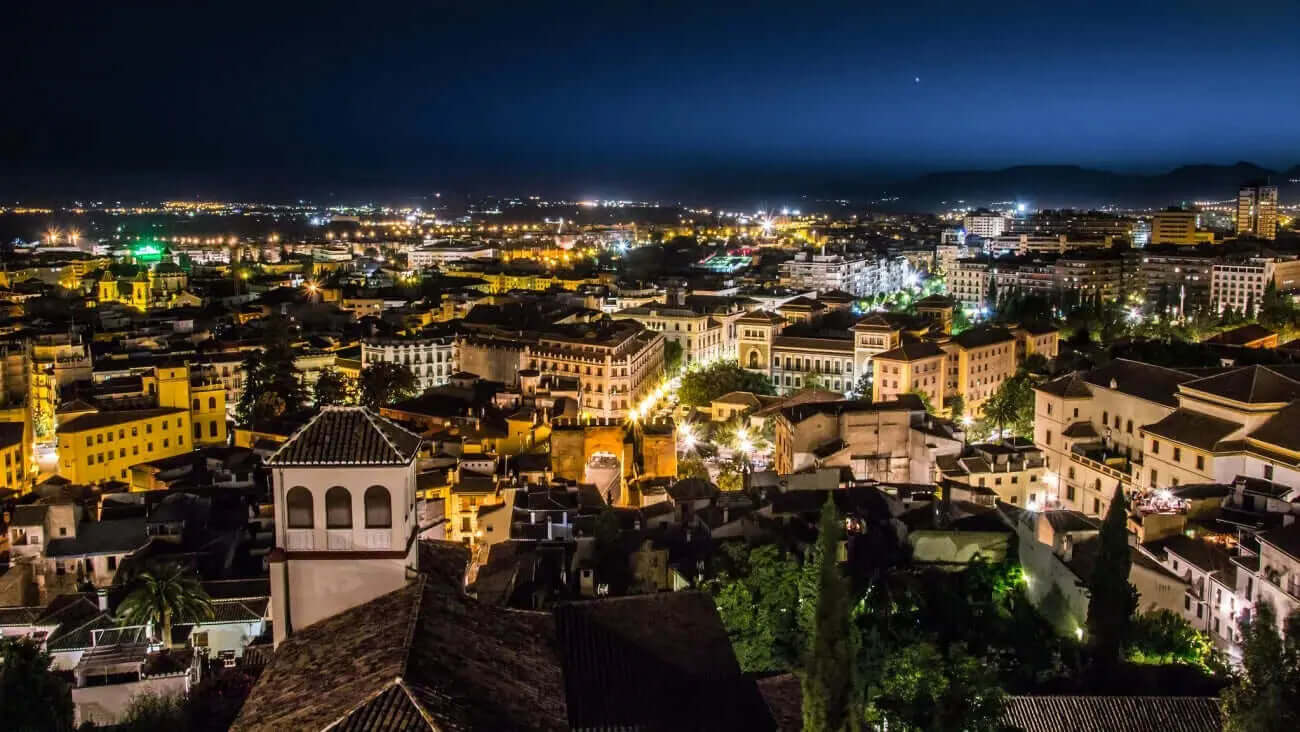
[0,0,1300,196]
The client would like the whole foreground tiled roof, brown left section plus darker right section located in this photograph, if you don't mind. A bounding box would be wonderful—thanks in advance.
[233,576,774,732]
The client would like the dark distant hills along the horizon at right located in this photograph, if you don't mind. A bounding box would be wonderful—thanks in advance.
[872,163,1300,211]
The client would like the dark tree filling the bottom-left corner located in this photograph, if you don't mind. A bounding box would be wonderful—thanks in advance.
[0,638,73,732]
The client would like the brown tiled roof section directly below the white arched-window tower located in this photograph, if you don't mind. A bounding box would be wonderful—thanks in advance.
[233,576,567,731]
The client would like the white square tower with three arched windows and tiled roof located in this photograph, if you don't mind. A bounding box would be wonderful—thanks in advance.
[268,407,421,646]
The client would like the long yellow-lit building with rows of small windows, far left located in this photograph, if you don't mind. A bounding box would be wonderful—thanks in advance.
[59,407,194,485]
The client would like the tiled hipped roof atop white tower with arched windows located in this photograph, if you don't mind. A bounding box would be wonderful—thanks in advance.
[269,407,420,465]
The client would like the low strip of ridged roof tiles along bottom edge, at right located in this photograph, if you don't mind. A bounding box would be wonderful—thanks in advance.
[1001,696,1223,732]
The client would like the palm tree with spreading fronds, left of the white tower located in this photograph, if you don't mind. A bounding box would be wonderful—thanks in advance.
[117,562,212,647]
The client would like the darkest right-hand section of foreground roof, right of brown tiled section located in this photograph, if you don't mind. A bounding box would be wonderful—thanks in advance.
[555,592,775,731]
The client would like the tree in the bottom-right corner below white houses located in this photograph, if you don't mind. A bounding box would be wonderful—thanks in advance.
[1223,602,1300,732]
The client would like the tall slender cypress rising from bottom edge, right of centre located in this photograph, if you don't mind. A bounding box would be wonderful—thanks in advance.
[801,495,862,732]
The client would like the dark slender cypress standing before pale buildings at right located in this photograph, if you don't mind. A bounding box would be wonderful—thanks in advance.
[1088,484,1138,672]
